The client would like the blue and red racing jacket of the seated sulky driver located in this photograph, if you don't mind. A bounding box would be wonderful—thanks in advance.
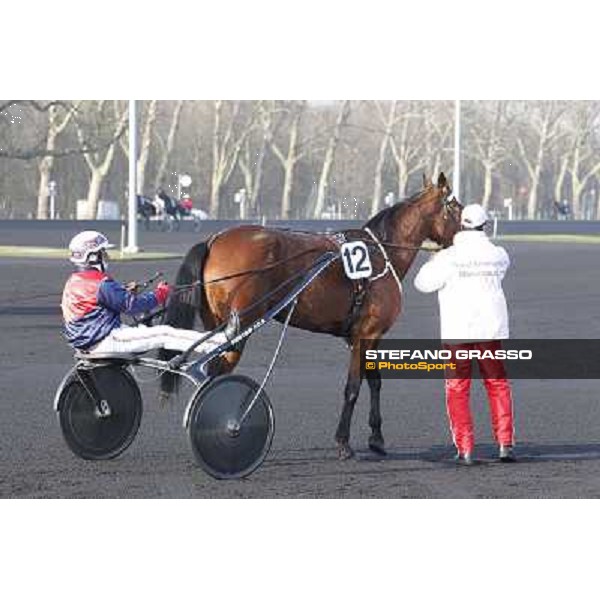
[61,269,158,350]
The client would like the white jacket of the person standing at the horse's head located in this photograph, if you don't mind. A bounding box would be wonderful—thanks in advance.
[415,231,510,340]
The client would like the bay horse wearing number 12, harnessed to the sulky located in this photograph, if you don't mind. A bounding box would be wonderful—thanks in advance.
[161,173,462,459]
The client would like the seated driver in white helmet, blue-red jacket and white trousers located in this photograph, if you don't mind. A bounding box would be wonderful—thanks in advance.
[61,231,239,355]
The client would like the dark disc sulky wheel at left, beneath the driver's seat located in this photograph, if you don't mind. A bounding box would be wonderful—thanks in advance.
[58,365,142,460]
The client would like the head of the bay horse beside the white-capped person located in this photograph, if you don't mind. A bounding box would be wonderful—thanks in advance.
[423,173,463,248]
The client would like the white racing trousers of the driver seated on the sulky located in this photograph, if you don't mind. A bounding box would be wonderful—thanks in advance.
[89,325,227,354]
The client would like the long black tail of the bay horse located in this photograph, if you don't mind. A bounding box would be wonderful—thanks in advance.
[158,242,209,395]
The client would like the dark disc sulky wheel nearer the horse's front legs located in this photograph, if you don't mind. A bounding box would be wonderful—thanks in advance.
[188,375,274,479]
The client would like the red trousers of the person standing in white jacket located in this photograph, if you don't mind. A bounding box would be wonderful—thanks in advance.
[444,340,514,454]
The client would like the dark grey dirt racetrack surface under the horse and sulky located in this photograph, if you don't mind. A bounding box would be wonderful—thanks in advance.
[0,236,600,498]
